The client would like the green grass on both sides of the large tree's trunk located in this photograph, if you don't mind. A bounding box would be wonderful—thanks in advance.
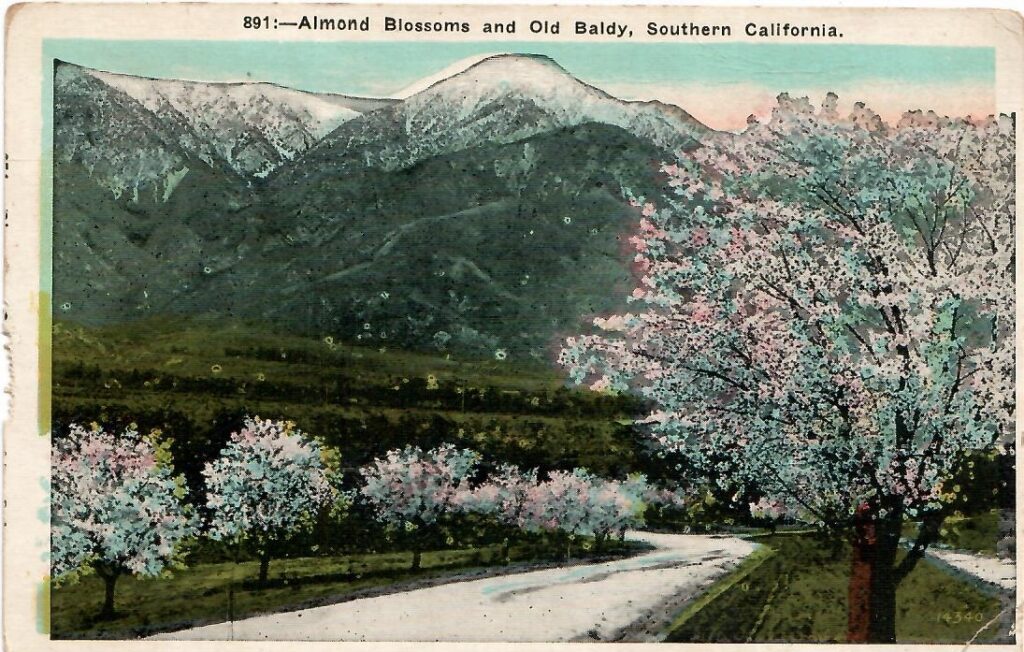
[667,534,1002,644]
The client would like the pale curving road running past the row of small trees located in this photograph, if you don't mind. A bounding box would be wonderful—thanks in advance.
[153,532,757,642]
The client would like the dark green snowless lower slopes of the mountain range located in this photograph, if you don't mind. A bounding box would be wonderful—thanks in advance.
[53,113,669,358]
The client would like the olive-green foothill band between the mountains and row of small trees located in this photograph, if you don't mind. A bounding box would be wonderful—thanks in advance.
[53,320,642,497]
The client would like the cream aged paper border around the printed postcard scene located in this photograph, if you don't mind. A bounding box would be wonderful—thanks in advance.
[3,3,1024,650]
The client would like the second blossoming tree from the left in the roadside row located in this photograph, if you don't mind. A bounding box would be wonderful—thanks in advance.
[203,417,340,584]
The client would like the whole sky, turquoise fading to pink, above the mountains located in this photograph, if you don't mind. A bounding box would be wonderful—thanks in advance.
[44,40,995,129]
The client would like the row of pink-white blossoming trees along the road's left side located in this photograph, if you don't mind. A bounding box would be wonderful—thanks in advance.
[50,419,680,617]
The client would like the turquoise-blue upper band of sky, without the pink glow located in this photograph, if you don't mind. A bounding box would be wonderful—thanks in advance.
[46,40,995,95]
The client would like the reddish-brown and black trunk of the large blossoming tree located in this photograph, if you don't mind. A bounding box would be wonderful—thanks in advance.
[847,507,900,643]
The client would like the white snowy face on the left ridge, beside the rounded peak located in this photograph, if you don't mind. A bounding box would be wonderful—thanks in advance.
[87,70,361,176]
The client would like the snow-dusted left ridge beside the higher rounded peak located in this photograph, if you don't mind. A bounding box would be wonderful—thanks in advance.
[54,62,397,201]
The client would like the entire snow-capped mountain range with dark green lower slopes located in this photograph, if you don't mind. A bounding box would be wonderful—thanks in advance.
[53,55,709,355]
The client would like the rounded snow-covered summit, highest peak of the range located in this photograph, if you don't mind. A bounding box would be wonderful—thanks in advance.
[283,54,709,177]
